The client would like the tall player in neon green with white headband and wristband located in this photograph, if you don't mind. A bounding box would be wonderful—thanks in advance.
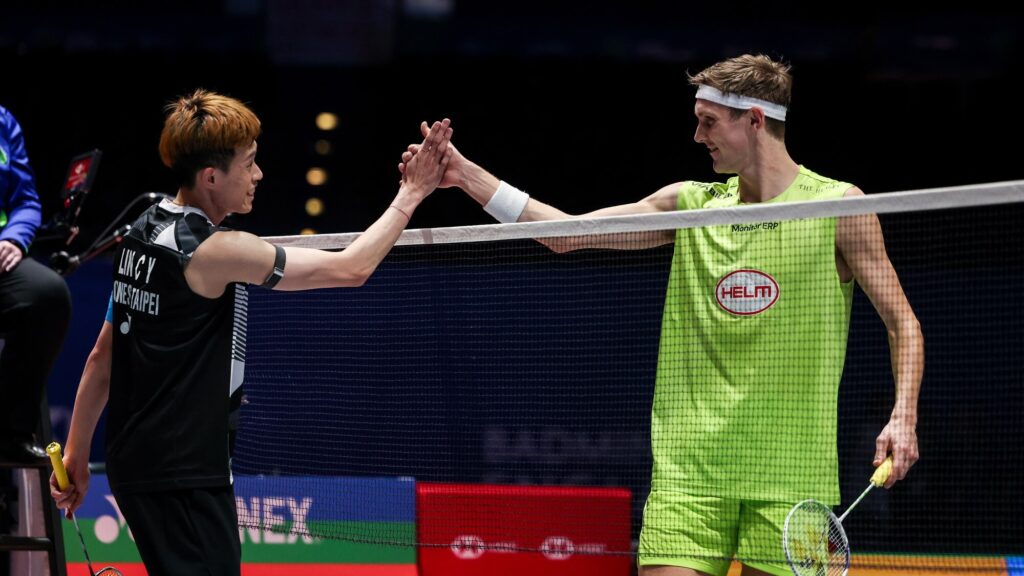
[399,54,924,576]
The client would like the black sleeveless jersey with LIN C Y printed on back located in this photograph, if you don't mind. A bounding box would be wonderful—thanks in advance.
[106,200,248,492]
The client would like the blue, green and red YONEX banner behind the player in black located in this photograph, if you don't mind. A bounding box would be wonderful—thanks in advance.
[61,475,416,565]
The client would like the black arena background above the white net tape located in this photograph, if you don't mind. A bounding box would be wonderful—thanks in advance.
[0,0,1024,239]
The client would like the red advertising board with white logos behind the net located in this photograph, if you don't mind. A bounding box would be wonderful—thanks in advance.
[416,483,633,576]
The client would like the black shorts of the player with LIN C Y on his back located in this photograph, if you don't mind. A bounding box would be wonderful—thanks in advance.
[114,486,242,576]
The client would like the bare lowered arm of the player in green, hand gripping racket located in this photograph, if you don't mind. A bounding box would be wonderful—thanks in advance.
[836,188,925,488]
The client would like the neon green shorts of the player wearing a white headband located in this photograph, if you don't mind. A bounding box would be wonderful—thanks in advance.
[637,490,793,576]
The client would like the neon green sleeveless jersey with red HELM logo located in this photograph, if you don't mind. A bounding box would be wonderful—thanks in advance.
[651,163,853,504]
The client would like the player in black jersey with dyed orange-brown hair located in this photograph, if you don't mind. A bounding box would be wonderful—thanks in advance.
[50,89,452,576]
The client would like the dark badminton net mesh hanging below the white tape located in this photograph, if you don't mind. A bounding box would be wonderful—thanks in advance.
[232,182,1024,574]
